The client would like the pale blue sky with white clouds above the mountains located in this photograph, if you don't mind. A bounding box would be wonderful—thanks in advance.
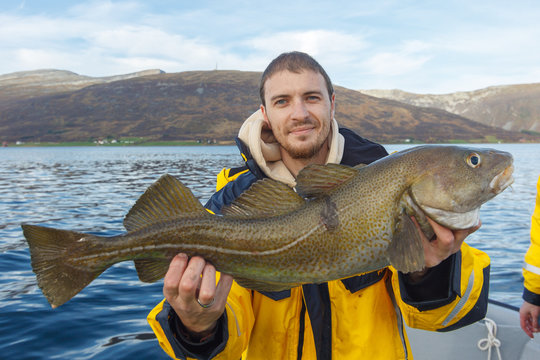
[0,0,540,94]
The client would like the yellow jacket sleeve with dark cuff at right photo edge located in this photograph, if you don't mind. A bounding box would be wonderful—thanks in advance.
[523,177,540,306]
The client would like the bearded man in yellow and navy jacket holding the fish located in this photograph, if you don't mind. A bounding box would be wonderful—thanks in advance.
[148,52,489,360]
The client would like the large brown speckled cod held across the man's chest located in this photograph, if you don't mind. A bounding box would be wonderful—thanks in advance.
[22,146,513,307]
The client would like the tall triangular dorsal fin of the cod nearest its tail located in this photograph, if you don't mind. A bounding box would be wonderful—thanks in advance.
[124,174,208,231]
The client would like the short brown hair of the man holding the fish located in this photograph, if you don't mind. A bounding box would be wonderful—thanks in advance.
[259,51,334,106]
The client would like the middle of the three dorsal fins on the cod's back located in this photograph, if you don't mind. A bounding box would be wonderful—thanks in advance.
[221,178,305,218]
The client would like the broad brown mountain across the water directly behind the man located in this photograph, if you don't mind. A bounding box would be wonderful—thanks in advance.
[0,70,538,142]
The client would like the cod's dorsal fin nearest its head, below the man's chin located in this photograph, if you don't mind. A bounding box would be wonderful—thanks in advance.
[296,164,359,198]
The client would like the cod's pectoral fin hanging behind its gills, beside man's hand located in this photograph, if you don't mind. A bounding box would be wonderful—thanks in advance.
[387,212,425,273]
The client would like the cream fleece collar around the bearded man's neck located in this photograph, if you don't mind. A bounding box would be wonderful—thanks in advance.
[238,109,345,187]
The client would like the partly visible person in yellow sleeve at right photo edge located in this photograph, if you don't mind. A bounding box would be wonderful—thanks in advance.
[519,177,540,338]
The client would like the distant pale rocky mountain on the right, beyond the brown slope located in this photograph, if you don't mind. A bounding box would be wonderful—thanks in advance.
[360,83,540,134]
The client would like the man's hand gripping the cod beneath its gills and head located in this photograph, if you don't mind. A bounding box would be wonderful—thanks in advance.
[409,217,482,281]
